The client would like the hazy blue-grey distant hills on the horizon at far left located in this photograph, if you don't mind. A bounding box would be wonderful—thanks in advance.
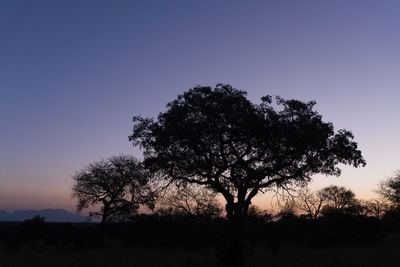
[0,209,88,222]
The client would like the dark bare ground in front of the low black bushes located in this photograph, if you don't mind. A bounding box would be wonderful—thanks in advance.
[0,242,400,267]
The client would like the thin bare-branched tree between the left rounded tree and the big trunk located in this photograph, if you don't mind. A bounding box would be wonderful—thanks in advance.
[160,185,222,217]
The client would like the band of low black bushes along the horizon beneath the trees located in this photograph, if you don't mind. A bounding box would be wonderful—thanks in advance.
[0,210,400,265]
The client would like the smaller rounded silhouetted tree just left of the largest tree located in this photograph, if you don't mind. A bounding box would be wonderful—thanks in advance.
[72,155,155,222]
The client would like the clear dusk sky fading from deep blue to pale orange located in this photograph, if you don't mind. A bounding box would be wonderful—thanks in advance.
[0,0,400,214]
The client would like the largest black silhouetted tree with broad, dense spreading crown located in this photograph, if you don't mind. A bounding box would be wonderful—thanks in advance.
[129,84,365,224]
